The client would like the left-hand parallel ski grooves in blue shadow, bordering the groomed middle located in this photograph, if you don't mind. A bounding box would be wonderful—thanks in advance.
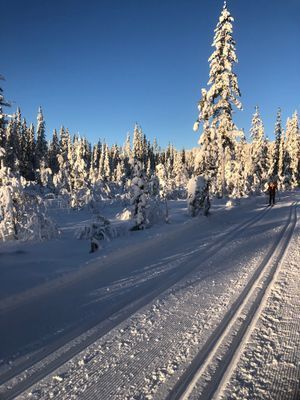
[0,207,270,400]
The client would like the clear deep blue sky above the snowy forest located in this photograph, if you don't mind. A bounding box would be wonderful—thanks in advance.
[0,0,300,148]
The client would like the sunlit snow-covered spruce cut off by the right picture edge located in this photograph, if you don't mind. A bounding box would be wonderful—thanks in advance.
[283,111,300,188]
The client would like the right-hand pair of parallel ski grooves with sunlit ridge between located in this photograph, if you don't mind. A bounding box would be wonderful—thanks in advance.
[166,202,298,400]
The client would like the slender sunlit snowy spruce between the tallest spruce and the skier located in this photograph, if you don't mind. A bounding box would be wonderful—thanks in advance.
[250,106,267,193]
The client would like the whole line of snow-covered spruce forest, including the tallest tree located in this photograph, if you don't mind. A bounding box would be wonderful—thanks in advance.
[0,2,300,238]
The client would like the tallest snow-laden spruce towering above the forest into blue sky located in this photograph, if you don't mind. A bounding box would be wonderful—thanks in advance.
[194,1,242,195]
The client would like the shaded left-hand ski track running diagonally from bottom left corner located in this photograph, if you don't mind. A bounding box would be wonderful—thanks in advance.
[0,208,269,400]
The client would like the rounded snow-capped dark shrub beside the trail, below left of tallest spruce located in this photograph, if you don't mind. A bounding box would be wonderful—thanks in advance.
[187,176,210,217]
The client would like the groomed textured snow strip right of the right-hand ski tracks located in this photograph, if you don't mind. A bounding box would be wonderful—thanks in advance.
[218,203,300,400]
